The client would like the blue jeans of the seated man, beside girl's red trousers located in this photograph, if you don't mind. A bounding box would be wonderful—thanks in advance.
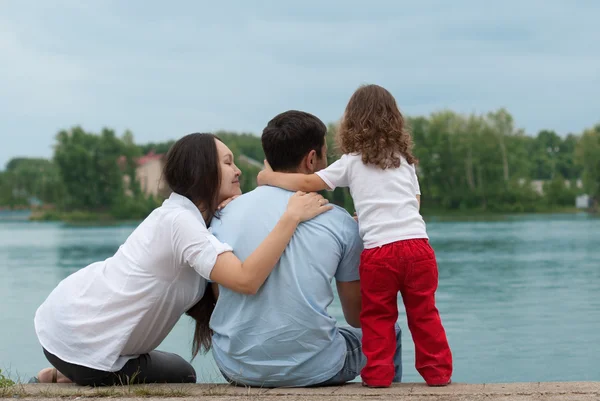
[315,324,402,386]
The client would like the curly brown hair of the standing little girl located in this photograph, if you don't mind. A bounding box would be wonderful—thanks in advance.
[337,85,417,170]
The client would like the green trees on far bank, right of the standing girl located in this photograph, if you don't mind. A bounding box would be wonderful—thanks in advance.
[408,109,592,213]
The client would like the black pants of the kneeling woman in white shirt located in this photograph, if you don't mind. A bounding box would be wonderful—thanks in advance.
[44,349,196,386]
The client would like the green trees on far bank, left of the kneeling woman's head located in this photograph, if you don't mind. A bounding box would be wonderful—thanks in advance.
[0,127,160,220]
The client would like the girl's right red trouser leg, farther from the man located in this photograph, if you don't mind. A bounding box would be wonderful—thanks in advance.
[399,239,452,386]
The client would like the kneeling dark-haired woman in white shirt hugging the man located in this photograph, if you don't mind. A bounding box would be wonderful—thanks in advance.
[35,134,331,386]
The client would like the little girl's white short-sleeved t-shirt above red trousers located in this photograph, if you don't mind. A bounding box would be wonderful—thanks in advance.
[316,154,428,249]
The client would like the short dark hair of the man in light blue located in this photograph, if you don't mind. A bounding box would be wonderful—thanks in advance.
[261,110,327,171]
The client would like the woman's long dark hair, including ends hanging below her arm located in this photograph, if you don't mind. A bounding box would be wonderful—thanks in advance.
[163,133,221,358]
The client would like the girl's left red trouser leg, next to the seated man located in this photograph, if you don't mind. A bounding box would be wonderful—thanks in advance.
[360,246,399,387]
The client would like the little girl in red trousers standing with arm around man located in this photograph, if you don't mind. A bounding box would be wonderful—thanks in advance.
[257,85,452,387]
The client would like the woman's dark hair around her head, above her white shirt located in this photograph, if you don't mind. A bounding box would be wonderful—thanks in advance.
[163,133,221,224]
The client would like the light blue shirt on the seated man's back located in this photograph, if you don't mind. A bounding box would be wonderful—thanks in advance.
[210,187,362,386]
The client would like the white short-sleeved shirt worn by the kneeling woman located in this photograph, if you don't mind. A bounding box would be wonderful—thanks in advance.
[34,193,232,372]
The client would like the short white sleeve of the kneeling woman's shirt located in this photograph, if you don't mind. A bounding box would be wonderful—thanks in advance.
[172,213,233,280]
